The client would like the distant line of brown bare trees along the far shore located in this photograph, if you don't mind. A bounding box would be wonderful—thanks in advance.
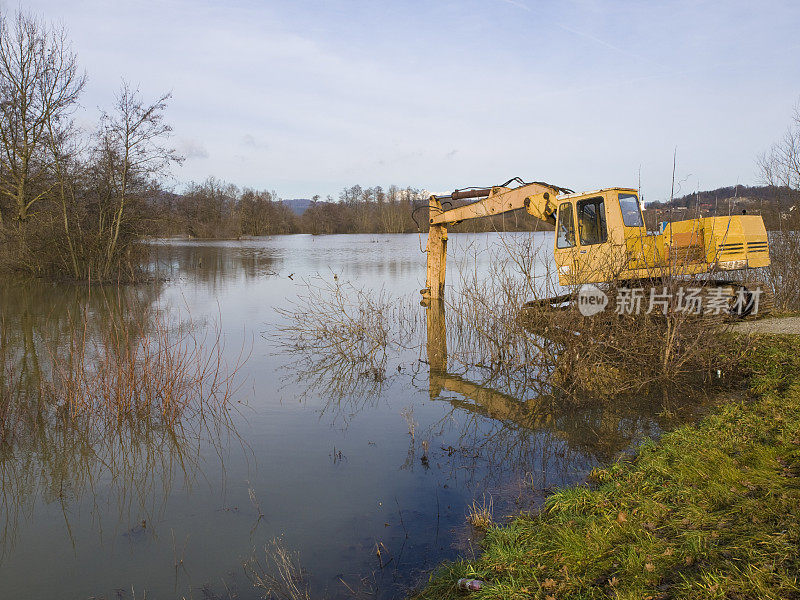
[152,177,798,239]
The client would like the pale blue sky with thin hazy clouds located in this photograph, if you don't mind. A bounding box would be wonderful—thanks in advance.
[10,0,800,202]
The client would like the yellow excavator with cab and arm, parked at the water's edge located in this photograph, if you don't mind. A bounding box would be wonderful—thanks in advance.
[422,178,770,314]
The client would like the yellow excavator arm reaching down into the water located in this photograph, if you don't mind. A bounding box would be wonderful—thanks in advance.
[422,178,572,304]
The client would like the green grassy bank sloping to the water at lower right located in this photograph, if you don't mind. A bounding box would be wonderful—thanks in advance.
[416,337,800,600]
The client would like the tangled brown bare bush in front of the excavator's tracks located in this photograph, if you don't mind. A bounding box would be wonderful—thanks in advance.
[446,233,744,401]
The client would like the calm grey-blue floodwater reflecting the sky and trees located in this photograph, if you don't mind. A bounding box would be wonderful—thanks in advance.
[0,233,688,599]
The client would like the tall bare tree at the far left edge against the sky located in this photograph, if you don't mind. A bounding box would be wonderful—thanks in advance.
[0,12,86,224]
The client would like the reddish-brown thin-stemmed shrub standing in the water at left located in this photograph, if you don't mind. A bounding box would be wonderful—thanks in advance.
[43,304,247,427]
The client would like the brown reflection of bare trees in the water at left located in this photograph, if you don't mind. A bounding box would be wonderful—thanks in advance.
[0,281,238,562]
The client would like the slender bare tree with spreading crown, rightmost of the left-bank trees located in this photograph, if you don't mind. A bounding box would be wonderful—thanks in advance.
[97,81,183,277]
